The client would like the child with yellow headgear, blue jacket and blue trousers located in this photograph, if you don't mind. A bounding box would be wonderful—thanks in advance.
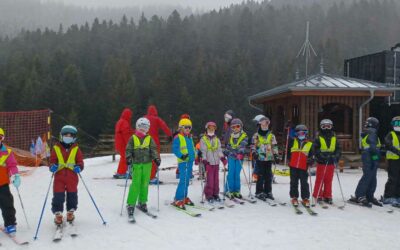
[172,118,196,209]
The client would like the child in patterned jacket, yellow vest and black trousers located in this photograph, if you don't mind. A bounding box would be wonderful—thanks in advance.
[251,115,279,200]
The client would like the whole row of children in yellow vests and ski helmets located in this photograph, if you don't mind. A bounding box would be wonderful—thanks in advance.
[0,112,400,234]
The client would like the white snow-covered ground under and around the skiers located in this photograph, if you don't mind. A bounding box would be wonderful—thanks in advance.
[4,155,400,250]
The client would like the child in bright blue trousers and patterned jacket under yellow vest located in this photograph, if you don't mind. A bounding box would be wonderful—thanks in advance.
[224,118,248,199]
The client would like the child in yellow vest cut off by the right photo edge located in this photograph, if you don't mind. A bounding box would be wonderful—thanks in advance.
[383,116,400,204]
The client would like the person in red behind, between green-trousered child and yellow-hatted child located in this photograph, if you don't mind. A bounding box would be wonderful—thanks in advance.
[144,105,172,184]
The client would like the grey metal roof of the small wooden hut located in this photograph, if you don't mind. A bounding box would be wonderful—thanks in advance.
[249,73,399,101]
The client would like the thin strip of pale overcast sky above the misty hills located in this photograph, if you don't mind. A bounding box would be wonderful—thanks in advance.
[43,0,262,9]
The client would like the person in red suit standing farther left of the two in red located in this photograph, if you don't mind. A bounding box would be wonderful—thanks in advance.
[114,108,134,179]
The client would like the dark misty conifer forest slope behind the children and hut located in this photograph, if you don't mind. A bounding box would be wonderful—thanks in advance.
[0,0,400,142]
